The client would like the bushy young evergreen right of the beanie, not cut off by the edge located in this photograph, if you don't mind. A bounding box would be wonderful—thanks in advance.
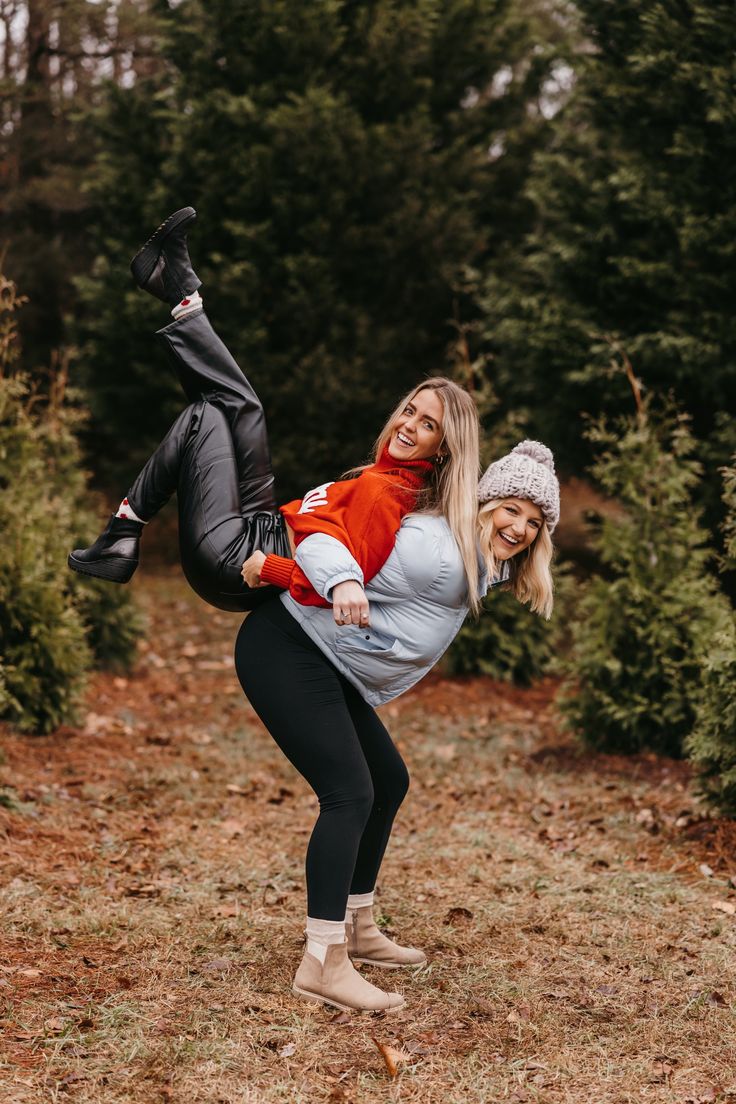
[561,405,730,755]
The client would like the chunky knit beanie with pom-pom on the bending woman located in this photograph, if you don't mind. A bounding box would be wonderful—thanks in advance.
[478,440,559,532]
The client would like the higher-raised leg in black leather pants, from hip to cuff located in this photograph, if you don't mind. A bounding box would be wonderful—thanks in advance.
[158,310,276,513]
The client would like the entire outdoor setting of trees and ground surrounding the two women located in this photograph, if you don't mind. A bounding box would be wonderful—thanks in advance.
[0,0,736,1104]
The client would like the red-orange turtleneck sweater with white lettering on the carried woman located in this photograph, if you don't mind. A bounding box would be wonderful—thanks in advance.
[260,448,433,607]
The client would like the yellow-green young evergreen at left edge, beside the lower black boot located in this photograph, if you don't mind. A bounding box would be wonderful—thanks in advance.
[0,277,143,732]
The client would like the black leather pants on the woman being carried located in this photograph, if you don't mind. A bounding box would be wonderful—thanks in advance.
[128,311,291,611]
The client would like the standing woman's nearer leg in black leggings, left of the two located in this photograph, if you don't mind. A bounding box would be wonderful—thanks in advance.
[235,602,374,921]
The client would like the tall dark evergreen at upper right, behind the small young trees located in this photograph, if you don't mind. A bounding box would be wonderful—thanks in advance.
[486,0,736,490]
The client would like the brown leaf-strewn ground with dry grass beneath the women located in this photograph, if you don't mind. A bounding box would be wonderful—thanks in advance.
[0,569,736,1104]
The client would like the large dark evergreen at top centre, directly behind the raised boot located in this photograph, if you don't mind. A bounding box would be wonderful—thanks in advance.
[76,0,562,496]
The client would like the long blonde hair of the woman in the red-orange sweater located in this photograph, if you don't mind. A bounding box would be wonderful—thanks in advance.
[353,375,480,613]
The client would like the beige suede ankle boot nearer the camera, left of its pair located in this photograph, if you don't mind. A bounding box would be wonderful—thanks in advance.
[292,942,404,1012]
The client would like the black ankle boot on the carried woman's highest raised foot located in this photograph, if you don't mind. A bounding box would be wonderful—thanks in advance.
[130,208,202,307]
